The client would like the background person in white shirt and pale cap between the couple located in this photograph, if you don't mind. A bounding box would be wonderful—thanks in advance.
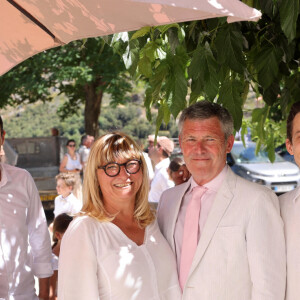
[148,136,174,203]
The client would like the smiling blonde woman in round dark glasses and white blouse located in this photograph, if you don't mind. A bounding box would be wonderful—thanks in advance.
[58,133,181,300]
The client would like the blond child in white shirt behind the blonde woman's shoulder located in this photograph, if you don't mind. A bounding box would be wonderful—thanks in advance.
[54,173,82,218]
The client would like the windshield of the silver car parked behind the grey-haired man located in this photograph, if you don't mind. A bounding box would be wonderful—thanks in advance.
[231,144,285,164]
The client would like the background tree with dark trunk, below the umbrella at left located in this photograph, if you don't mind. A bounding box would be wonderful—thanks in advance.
[0,38,131,135]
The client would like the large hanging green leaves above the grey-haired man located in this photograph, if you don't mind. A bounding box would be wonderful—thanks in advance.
[111,0,300,159]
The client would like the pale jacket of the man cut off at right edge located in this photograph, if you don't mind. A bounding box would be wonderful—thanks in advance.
[279,187,300,300]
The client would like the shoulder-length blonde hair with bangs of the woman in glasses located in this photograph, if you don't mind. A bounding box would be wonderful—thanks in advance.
[81,132,154,227]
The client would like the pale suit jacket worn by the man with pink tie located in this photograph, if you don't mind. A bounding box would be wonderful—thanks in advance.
[158,169,286,300]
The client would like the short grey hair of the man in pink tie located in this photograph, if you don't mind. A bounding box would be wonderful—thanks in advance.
[178,100,233,140]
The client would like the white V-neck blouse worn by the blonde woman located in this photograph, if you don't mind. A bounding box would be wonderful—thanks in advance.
[58,216,181,300]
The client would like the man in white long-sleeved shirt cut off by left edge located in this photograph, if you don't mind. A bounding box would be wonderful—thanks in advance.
[0,117,53,300]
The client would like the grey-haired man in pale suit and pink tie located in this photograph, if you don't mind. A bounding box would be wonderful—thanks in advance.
[158,101,286,300]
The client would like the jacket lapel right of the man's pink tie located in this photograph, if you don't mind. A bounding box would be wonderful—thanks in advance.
[190,169,236,274]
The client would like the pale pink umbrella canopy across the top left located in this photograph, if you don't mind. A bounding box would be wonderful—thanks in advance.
[0,0,261,75]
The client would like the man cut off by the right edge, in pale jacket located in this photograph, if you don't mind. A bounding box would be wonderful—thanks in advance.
[279,102,300,300]
